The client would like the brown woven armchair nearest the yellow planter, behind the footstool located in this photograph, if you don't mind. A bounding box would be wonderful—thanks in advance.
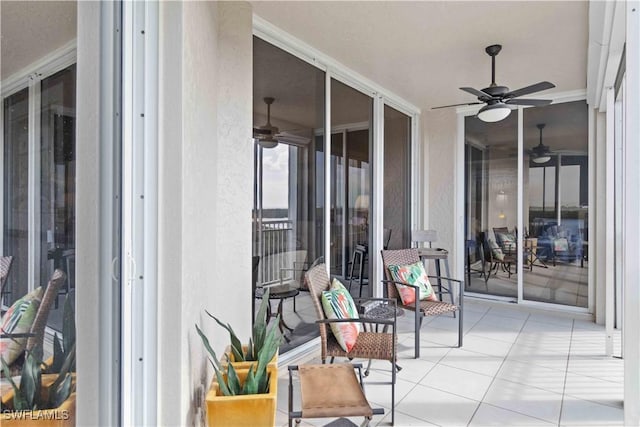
[306,264,398,423]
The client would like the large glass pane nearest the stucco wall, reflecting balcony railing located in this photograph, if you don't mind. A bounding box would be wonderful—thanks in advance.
[254,37,325,353]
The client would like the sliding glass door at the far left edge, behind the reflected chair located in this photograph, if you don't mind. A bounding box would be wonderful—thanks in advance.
[0,64,76,330]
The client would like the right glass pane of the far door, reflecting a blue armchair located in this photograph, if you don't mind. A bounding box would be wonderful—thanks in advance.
[523,101,589,307]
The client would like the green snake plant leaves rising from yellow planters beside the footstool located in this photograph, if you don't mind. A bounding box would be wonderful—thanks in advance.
[195,290,282,396]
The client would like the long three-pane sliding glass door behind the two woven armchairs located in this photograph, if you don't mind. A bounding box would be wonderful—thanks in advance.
[252,33,417,353]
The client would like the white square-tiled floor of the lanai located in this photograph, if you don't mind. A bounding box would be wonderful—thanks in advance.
[276,300,623,426]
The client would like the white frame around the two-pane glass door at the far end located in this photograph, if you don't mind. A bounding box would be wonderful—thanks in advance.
[454,90,595,313]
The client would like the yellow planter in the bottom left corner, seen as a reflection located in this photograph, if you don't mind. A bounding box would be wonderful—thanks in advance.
[0,374,76,427]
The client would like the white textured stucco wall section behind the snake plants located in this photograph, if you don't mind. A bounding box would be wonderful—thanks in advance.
[158,2,252,425]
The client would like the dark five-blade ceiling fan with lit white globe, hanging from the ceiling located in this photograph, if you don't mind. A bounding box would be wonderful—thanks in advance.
[433,44,556,122]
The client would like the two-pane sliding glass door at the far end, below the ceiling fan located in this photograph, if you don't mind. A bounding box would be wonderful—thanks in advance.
[465,101,589,308]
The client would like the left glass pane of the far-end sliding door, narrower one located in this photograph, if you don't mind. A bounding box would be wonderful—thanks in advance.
[465,114,518,298]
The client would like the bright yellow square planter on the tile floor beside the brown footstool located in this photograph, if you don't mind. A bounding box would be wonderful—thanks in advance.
[206,365,278,427]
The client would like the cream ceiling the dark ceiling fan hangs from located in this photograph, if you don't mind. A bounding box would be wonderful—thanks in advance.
[252,1,589,149]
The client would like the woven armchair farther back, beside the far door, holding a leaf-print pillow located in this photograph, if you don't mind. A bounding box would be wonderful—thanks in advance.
[382,248,464,359]
